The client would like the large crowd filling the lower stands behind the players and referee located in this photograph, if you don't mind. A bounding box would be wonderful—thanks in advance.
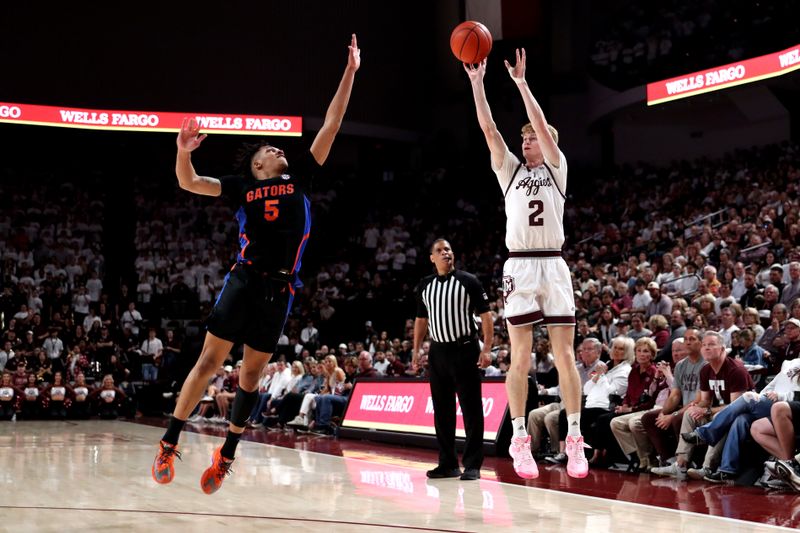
[0,132,800,490]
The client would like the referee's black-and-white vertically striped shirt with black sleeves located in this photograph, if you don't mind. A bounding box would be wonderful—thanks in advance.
[417,270,489,342]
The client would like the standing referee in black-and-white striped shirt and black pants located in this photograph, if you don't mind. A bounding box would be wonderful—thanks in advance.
[412,239,494,480]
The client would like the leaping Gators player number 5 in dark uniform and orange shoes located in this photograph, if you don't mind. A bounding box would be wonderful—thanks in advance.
[152,35,361,494]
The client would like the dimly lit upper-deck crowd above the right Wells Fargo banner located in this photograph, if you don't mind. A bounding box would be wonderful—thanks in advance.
[590,0,797,89]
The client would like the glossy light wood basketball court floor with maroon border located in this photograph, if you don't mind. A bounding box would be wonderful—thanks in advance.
[0,419,800,533]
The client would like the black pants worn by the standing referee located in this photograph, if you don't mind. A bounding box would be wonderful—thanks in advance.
[428,339,483,469]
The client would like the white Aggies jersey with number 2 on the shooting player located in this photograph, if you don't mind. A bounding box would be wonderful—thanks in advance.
[492,148,567,251]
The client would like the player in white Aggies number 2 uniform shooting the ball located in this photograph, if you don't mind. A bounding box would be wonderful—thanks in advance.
[464,49,589,479]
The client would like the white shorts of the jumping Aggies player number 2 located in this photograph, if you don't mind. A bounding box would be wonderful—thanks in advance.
[503,252,575,326]
